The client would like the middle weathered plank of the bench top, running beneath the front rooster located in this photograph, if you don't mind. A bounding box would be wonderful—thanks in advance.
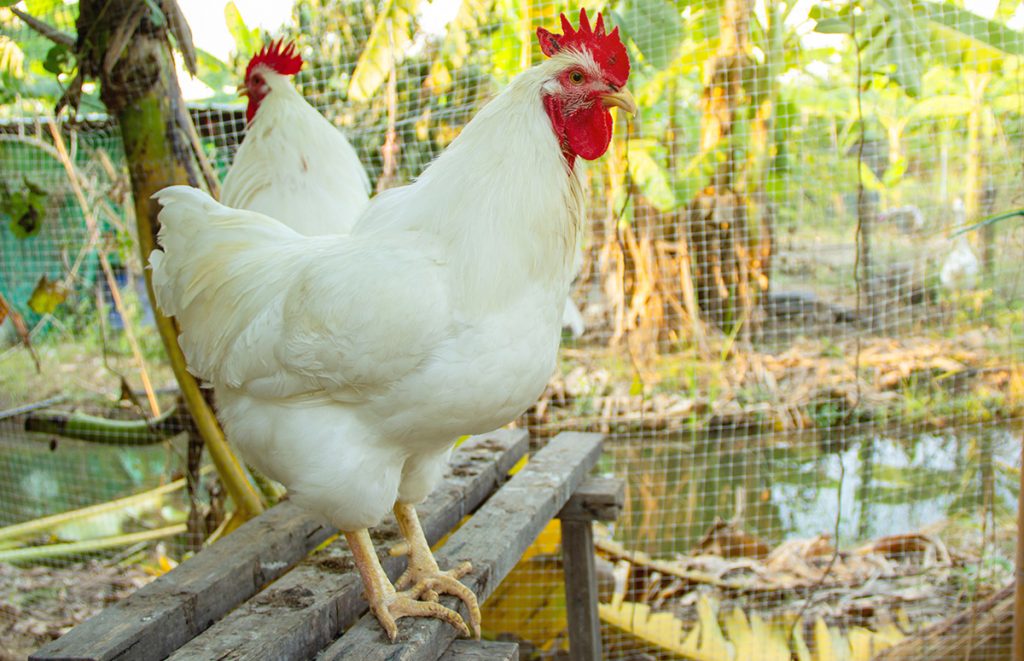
[171,430,528,661]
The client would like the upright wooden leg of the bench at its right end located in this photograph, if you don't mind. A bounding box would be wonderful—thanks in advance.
[562,519,602,661]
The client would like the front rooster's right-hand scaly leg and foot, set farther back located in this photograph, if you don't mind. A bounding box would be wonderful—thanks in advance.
[391,502,480,638]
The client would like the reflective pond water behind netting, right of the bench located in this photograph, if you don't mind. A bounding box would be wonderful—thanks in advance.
[602,427,1020,556]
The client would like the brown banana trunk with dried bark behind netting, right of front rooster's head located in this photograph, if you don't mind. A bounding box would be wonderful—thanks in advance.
[686,0,771,339]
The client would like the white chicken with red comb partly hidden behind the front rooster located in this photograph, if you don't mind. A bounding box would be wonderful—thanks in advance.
[220,41,370,235]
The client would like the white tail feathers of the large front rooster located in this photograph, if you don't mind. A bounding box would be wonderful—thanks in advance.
[150,186,308,385]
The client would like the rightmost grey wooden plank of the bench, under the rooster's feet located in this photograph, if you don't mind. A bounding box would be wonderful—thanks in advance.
[317,433,602,661]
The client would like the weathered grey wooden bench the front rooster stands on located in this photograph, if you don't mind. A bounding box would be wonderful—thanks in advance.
[31,430,623,661]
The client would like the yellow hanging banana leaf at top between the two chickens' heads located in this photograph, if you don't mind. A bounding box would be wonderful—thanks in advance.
[348,0,417,101]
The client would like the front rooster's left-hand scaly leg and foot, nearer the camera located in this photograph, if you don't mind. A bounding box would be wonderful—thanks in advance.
[345,528,471,643]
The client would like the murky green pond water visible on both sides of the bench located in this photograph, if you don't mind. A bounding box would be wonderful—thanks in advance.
[6,421,1021,556]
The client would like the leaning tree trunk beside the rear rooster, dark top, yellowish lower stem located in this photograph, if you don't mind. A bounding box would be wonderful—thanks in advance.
[76,0,262,520]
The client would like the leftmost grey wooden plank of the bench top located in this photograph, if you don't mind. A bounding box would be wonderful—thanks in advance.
[31,501,335,661]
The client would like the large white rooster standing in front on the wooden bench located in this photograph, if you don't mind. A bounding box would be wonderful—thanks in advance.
[151,11,636,641]
